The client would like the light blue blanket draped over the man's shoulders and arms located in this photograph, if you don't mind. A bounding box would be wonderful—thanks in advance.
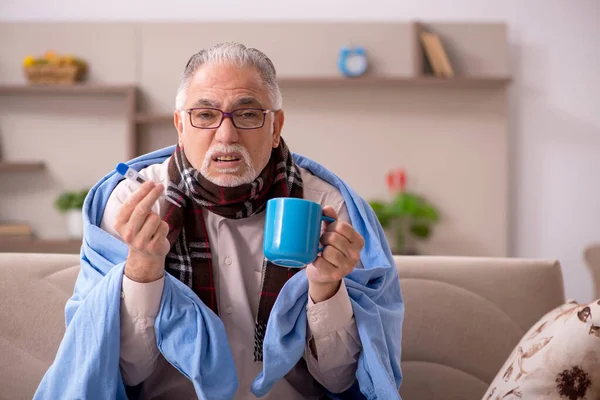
[34,146,404,400]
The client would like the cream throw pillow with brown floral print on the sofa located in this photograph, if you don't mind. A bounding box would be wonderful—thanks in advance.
[483,300,600,400]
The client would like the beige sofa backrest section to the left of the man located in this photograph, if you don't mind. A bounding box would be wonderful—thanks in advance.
[0,254,79,399]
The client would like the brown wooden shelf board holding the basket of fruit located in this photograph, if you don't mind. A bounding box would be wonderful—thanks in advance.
[0,83,135,95]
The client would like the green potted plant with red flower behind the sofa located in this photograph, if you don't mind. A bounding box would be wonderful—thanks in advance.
[369,169,440,255]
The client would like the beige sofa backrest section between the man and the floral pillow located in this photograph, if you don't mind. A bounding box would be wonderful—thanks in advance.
[395,256,565,400]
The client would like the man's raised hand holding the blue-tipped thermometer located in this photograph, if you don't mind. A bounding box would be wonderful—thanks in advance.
[115,181,171,283]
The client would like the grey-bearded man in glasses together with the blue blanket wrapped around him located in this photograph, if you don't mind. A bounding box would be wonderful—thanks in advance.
[35,43,404,400]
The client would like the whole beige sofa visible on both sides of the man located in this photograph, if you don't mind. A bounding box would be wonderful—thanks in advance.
[0,253,565,400]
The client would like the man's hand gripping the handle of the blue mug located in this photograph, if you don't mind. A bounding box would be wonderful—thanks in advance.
[306,206,365,303]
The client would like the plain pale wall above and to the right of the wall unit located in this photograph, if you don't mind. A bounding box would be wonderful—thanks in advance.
[0,0,600,301]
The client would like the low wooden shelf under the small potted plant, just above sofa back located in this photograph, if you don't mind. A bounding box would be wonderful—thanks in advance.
[0,236,81,254]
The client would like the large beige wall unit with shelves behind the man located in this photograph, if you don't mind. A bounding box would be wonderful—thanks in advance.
[0,20,511,256]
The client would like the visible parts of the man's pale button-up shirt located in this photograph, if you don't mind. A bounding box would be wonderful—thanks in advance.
[100,159,362,400]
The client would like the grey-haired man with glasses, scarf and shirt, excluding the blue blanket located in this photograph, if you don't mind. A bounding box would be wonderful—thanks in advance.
[102,44,364,400]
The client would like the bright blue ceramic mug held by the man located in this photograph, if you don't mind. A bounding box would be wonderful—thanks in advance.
[263,197,335,268]
